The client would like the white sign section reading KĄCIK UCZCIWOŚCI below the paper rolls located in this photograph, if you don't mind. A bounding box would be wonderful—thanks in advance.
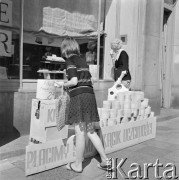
[101,117,156,154]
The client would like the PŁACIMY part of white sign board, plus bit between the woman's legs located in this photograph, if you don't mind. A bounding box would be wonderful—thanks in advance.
[25,135,97,175]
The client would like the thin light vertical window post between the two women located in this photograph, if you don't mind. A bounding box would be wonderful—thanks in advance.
[97,0,101,80]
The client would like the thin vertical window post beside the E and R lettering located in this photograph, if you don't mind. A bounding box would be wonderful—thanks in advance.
[19,0,24,89]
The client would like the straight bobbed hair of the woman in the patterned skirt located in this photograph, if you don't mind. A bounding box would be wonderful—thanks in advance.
[61,37,80,58]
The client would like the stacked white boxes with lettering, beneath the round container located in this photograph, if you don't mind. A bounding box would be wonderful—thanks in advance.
[30,99,68,142]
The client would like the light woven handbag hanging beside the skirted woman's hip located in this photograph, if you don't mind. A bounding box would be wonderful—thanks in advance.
[56,87,70,131]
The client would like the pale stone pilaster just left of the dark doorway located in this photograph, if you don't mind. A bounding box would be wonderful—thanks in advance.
[142,0,163,114]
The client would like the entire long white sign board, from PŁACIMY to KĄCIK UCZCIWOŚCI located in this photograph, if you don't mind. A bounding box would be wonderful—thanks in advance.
[25,117,156,175]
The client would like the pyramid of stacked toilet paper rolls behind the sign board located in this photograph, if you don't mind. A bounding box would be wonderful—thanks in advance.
[98,91,154,127]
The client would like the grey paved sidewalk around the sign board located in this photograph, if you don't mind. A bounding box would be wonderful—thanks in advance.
[0,109,179,180]
